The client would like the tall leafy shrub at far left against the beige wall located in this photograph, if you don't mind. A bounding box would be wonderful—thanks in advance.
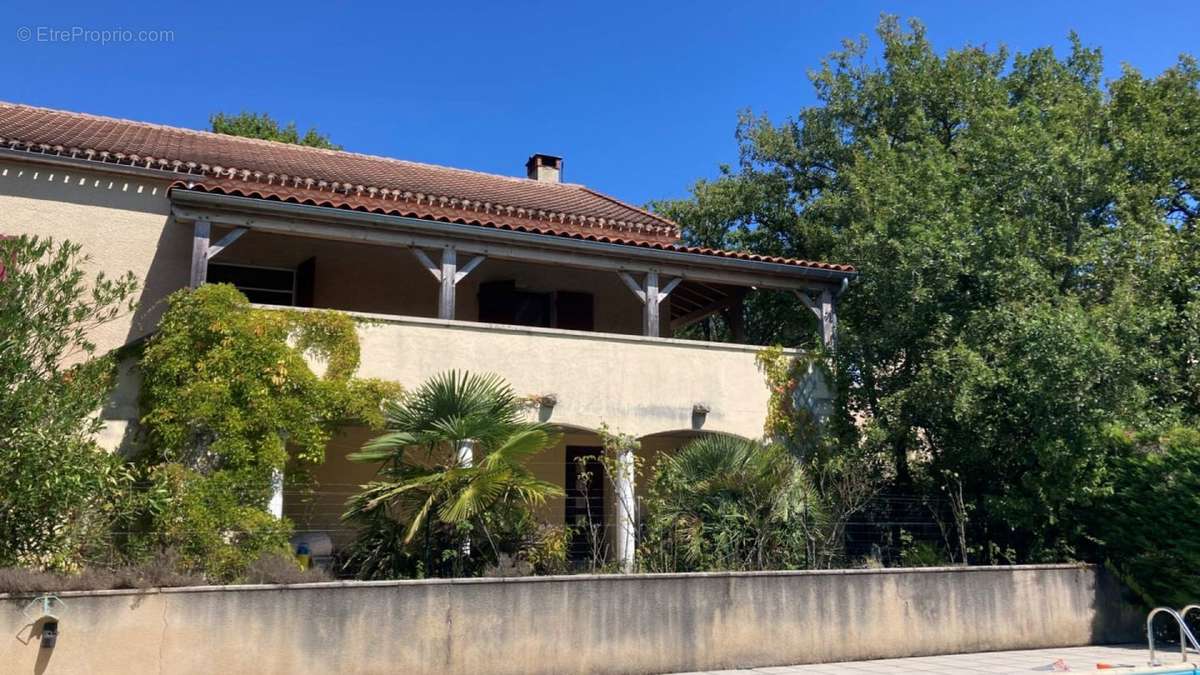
[0,237,137,571]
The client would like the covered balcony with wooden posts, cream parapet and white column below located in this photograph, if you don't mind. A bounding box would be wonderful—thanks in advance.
[172,190,853,561]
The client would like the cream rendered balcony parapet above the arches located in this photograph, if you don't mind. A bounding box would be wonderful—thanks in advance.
[343,315,782,437]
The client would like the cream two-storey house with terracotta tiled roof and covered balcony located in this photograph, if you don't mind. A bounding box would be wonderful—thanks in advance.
[0,103,854,561]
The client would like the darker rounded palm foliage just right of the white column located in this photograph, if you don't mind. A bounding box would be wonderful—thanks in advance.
[642,435,817,572]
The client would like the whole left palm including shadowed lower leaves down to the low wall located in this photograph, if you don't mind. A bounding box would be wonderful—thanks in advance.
[346,371,563,573]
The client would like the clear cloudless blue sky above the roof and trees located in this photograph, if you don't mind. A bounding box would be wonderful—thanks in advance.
[9,0,1200,203]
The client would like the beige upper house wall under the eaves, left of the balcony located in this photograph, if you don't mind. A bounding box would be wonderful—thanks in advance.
[0,161,192,353]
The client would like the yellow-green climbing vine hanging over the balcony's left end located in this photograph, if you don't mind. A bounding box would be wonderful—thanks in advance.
[135,285,398,580]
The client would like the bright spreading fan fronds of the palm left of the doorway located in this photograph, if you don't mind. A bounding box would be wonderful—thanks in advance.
[343,371,563,559]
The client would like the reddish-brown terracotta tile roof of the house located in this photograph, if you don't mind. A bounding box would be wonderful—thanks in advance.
[0,102,853,273]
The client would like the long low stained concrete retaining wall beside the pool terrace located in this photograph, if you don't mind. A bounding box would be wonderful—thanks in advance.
[0,566,1139,674]
